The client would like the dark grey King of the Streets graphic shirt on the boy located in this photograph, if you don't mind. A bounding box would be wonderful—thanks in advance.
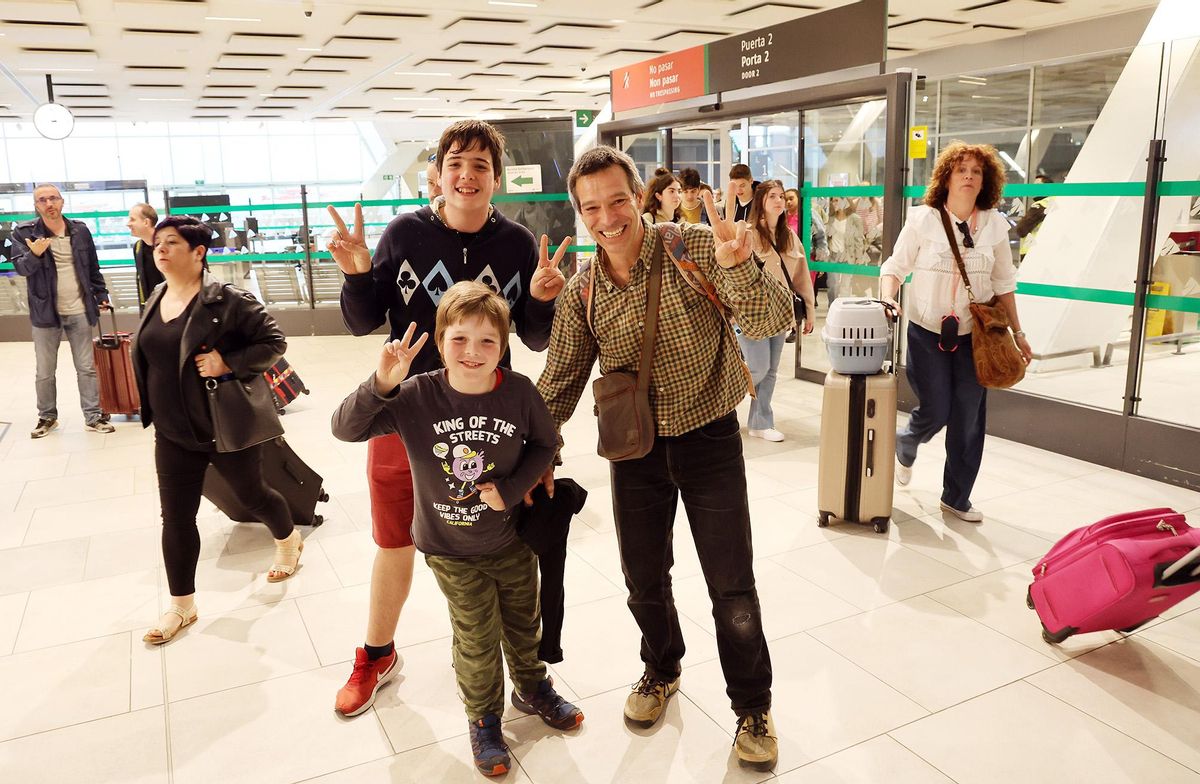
[334,370,557,557]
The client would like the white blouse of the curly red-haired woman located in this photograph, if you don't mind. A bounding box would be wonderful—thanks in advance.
[880,205,1016,335]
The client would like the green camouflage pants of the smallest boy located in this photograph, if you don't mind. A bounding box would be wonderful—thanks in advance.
[425,541,546,722]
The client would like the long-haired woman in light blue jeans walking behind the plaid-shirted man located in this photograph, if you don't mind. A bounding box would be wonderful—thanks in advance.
[738,180,816,441]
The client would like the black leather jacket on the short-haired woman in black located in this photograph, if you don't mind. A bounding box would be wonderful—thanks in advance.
[131,270,288,441]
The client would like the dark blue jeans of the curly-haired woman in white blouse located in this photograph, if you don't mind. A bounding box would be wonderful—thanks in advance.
[896,322,988,511]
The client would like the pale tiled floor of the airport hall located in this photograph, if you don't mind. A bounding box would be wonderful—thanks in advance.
[0,337,1200,784]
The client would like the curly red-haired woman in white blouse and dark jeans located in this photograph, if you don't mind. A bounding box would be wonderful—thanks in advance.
[880,142,1033,522]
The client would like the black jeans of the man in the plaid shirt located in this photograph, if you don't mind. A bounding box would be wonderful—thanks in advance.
[612,412,772,716]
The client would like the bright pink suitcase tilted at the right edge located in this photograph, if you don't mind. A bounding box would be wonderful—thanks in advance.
[1026,507,1200,644]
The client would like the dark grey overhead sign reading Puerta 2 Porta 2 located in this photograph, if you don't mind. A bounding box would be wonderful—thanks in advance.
[708,0,888,92]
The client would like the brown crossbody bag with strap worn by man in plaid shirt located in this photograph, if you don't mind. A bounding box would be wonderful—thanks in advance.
[587,237,664,461]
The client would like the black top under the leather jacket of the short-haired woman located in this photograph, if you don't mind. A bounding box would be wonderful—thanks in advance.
[138,297,212,448]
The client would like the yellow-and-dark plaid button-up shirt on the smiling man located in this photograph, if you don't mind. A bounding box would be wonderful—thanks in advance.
[538,216,792,436]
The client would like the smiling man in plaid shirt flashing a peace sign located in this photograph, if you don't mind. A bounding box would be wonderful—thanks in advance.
[538,146,792,770]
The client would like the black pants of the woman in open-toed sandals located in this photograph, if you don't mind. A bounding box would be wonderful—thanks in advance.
[154,433,293,597]
